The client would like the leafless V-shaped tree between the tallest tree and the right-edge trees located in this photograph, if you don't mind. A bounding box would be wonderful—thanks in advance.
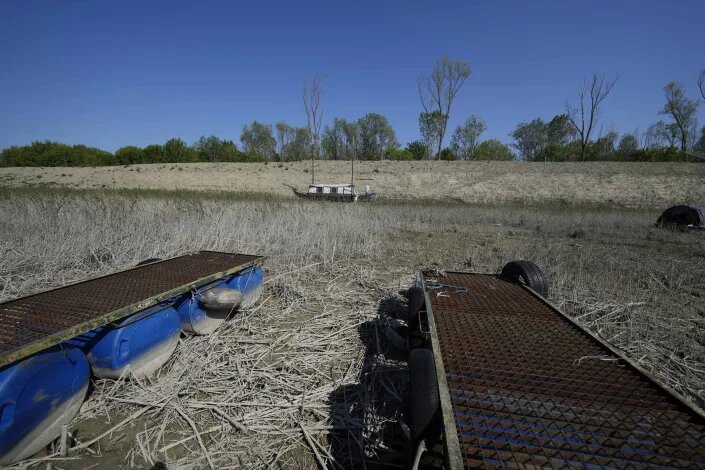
[565,72,617,160]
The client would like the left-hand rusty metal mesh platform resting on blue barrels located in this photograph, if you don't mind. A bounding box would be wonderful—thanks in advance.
[0,251,263,367]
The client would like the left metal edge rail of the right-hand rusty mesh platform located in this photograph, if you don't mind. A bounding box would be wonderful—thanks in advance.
[419,273,464,470]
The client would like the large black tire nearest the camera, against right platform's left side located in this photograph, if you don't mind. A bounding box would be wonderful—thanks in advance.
[409,349,441,442]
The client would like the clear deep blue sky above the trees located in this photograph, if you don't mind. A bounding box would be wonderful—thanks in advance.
[0,0,705,150]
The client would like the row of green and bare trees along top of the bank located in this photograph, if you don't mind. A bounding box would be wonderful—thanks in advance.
[0,58,705,166]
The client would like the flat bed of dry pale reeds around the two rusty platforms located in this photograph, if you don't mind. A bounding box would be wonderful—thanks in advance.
[0,190,705,468]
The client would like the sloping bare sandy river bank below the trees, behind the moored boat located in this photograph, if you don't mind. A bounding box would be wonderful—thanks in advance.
[0,161,705,209]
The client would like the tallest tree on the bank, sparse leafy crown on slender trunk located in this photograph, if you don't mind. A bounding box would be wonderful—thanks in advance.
[417,57,470,155]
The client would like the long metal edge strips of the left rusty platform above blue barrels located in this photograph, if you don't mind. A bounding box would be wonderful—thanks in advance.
[0,250,264,367]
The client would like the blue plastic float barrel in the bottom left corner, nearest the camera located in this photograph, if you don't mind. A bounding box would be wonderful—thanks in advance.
[0,346,90,465]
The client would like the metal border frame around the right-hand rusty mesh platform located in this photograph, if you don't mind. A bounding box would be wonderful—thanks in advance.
[417,271,705,470]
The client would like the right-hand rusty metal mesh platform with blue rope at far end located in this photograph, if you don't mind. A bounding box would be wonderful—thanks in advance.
[423,272,705,468]
